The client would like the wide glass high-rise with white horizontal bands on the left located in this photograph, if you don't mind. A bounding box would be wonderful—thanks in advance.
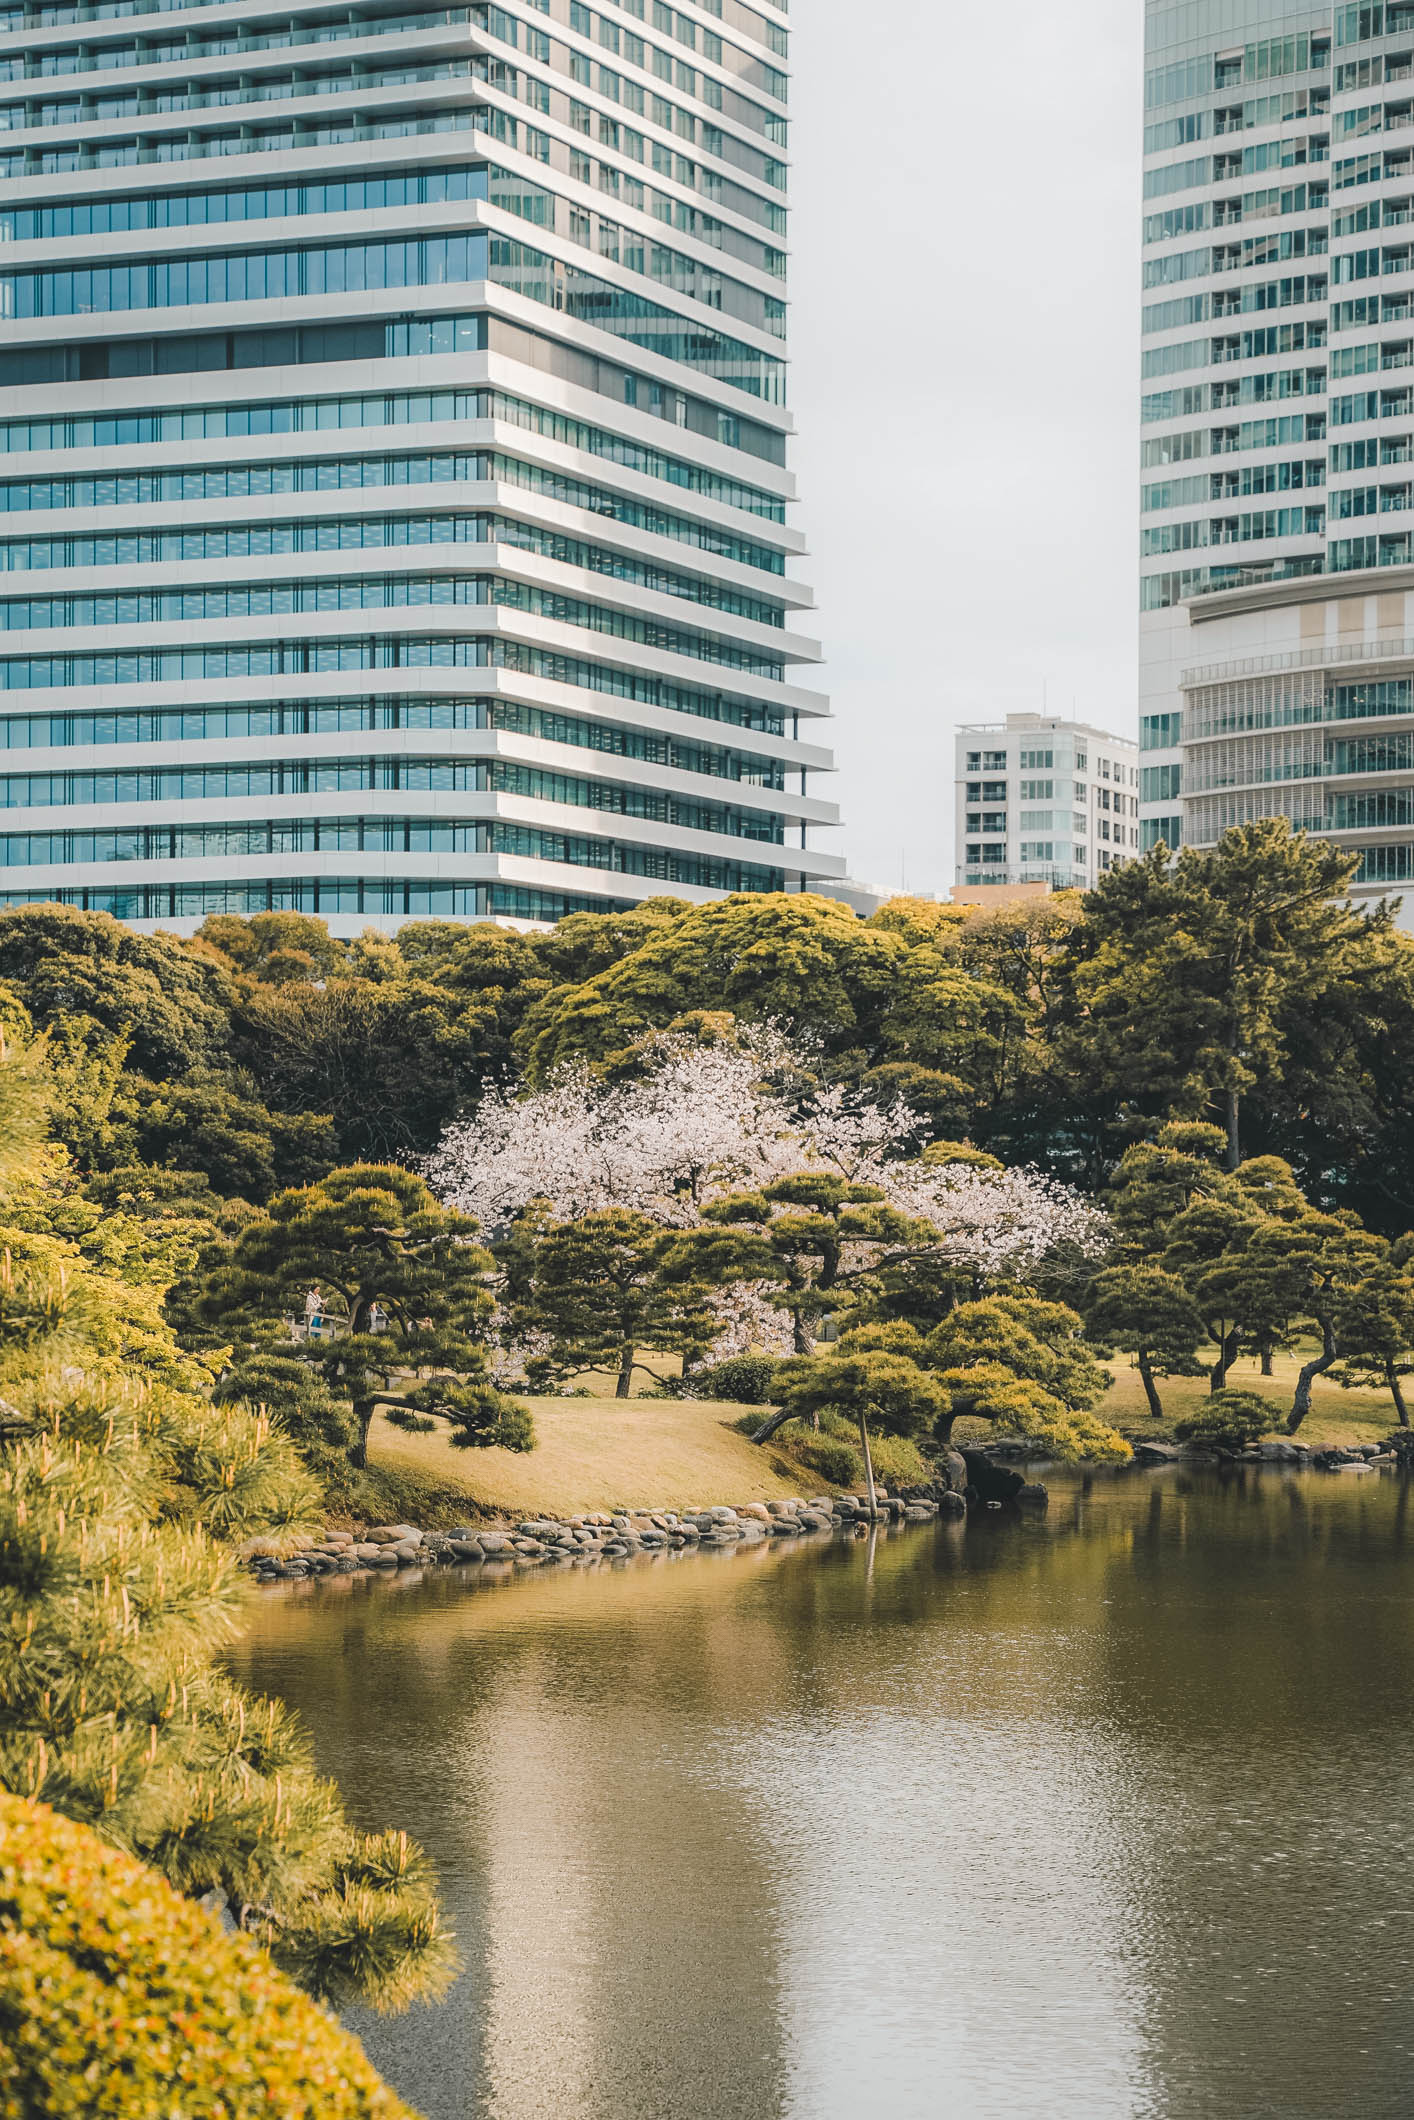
[0,0,844,933]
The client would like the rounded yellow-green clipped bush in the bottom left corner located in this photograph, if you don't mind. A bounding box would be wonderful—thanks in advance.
[0,1794,416,2120]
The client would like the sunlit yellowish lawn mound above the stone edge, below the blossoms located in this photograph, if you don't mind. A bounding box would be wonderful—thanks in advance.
[369,1397,829,1516]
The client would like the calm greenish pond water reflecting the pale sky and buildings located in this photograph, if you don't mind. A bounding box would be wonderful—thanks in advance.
[230,1469,1414,2120]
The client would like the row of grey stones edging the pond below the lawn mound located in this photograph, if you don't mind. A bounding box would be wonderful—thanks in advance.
[242,1486,967,1582]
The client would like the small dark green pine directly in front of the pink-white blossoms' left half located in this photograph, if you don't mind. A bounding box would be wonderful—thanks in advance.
[515,1206,714,1399]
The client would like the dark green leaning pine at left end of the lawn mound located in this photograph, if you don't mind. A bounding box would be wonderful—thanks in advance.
[193,1164,532,1467]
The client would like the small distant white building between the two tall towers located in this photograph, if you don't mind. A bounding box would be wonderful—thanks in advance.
[954,714,1138,890]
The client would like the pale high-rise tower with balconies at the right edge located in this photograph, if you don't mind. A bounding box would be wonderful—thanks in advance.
[1141,0,1414,911]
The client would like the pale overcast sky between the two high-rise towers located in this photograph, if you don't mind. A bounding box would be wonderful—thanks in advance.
[791,0,1143,893]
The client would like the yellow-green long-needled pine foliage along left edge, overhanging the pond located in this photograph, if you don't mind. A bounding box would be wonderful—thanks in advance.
[0,1017,454,2008]
